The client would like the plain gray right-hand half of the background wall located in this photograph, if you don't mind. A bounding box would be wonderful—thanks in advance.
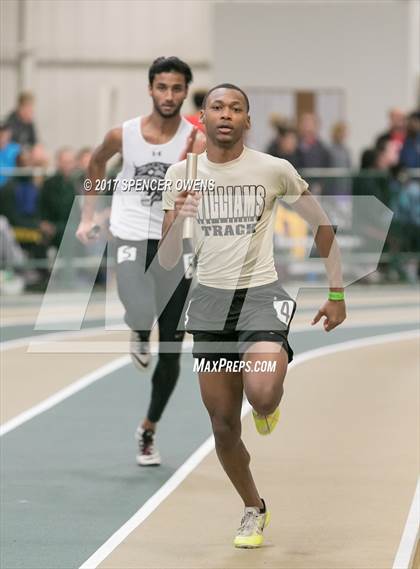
[214,0,420,160]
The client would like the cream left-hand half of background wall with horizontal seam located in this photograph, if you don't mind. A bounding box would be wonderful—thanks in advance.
[0,0,211,153]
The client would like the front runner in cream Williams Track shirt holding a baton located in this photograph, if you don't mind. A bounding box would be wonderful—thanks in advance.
[159,84,346,548]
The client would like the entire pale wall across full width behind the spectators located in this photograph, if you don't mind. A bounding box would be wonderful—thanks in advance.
[0,0,419,158]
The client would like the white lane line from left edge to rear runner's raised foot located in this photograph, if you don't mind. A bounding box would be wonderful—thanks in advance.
[0,356,131,437]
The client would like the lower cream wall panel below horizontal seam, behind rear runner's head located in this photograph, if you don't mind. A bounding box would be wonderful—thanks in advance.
[37,67,210,150]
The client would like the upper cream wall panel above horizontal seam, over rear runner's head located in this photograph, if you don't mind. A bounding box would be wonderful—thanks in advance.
[29,0,211,61]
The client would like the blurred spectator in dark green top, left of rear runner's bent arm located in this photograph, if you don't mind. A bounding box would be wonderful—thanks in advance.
[40,148,79,248]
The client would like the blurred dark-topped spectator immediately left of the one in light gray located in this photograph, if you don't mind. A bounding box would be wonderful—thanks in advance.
[297,113,330,168]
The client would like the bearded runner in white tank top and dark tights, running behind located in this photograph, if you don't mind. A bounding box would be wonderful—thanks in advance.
[76,57,205,466]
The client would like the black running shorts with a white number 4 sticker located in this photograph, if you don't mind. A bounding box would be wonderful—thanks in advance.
[185,281,296,362]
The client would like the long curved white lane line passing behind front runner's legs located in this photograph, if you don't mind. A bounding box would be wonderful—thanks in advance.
[79,330,419,569]
